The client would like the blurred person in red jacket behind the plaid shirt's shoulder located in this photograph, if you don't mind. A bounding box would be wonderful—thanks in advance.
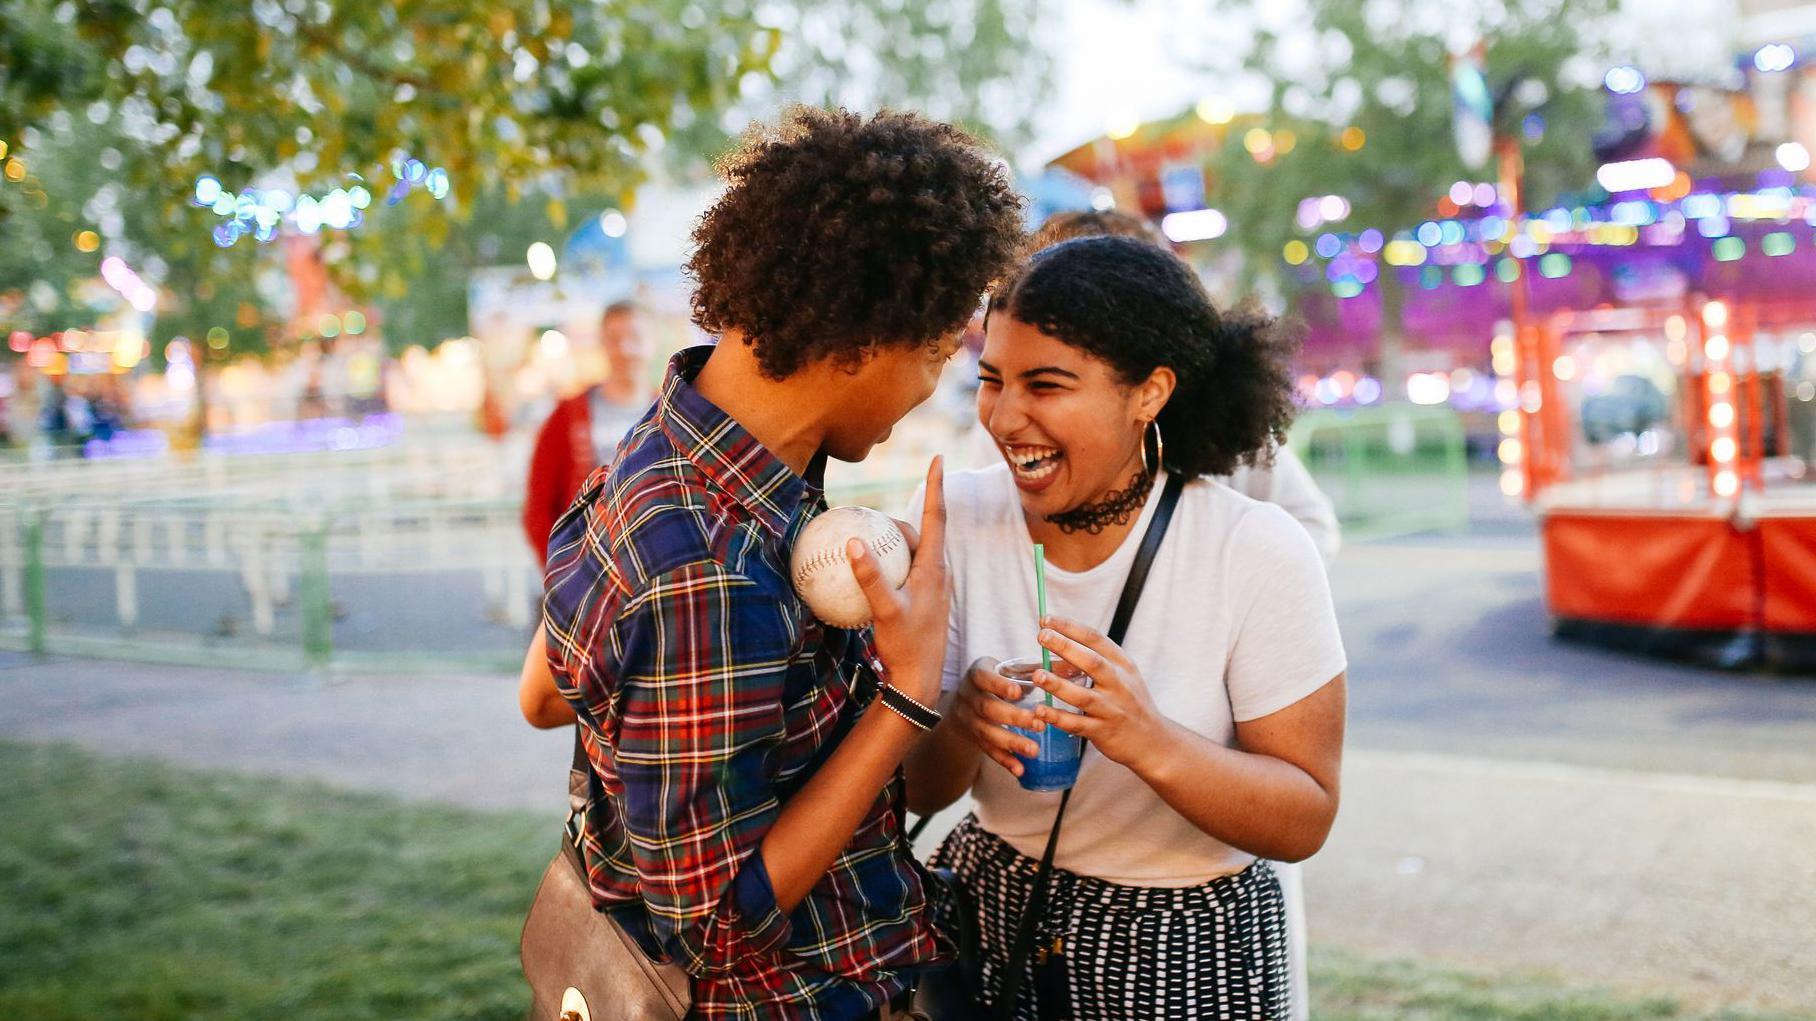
[523,302,654,565]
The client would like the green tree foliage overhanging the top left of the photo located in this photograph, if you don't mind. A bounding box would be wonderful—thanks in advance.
[0,0,1046,349]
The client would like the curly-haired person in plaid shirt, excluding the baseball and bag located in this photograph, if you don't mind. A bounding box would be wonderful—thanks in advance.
[521,109,1021,1021]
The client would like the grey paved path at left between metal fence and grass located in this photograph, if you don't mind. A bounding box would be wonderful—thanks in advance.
[0,654,574,812]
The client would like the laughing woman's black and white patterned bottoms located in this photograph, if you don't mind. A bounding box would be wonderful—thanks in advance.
[933,818,1289,1021]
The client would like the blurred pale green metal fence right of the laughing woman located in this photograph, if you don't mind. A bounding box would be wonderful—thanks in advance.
[1288,405,1469,540]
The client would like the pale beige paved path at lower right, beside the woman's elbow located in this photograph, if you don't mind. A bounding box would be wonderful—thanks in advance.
[1306,748,1816,1012]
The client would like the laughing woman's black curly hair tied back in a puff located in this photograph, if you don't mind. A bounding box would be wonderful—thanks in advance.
[990,236,1298,476]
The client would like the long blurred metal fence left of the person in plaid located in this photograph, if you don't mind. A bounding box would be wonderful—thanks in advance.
[0,441,539,670]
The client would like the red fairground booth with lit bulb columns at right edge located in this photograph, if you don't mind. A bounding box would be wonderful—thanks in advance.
[1502,298,1816,670]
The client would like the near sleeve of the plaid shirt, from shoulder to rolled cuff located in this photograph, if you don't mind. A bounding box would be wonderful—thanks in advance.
[614,563,794,977]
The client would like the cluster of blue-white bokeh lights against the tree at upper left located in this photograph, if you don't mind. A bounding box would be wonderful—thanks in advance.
[189,156,452,249]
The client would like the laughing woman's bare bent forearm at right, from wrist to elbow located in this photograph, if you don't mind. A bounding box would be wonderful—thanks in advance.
[1131,723,1337,861]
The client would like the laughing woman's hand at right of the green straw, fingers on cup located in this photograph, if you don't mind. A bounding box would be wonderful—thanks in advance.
[1033,616,1173,774]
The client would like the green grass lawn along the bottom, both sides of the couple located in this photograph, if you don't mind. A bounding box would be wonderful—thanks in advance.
[0,741,1816,1021]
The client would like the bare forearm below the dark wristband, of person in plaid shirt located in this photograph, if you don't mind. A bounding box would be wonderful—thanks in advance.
[759,703,921,914]
